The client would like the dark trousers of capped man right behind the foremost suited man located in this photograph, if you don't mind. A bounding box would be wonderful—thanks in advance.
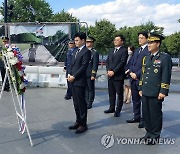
[86,78,95,105]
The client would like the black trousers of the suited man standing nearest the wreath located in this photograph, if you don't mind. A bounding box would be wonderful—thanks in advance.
[72,83,87,126]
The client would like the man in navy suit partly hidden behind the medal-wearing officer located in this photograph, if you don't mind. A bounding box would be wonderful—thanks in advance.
[126,32,149,128]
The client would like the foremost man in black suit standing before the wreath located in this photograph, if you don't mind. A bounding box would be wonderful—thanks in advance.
[68,32,91,134]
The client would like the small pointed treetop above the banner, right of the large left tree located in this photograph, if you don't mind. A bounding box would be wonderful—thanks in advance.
[51,9,79,22]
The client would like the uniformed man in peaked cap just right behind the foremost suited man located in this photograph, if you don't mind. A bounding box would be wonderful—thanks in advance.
[86,36,99,109]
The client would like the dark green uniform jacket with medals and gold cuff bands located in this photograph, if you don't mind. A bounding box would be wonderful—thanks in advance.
[139,52,172,97]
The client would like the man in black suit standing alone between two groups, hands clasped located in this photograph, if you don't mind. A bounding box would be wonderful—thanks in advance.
[104,35,128,117]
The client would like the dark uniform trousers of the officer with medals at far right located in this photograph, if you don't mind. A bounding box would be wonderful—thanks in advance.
[142,96,163,139]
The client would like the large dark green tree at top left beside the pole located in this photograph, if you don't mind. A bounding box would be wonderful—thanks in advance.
[0,0,52,22]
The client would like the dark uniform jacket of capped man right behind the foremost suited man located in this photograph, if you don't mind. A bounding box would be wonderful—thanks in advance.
[86,49,99,78]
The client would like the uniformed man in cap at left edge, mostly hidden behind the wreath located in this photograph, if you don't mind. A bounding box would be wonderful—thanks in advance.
[0,37,9,92]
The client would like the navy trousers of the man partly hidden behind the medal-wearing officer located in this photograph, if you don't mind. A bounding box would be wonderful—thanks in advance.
[131,80,141,119]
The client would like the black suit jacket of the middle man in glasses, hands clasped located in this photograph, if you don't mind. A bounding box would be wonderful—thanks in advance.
[106,46,128,80]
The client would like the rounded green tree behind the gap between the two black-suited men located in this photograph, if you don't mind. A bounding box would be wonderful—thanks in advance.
[89,19,116,54]
